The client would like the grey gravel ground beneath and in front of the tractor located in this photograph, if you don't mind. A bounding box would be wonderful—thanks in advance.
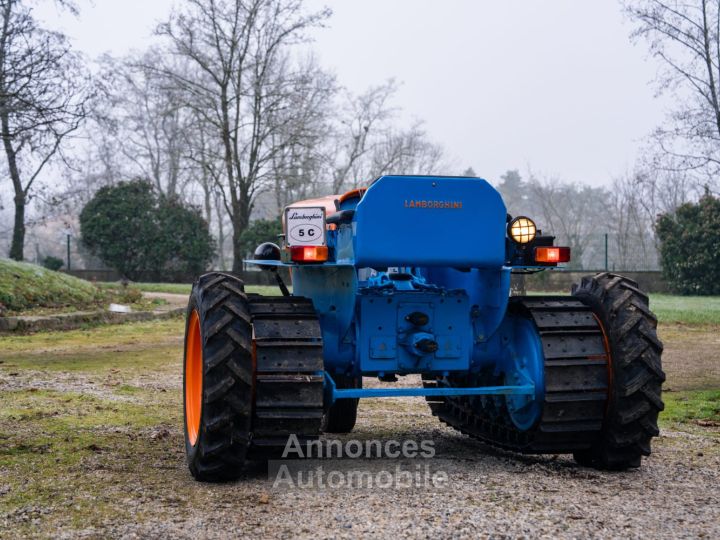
[36,380,720,538]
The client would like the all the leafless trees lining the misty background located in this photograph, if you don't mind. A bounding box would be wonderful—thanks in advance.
[0,0,720,296]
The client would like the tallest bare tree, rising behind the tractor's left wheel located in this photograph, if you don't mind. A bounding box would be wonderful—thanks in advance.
[158,0,329,271]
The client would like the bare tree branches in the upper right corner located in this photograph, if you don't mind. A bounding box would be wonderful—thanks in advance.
[625,0,720,184]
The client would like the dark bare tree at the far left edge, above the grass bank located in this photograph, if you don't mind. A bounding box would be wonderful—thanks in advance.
[0,0,89,260]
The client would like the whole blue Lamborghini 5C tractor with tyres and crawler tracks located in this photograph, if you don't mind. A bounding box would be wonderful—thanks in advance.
[184,176,665,481]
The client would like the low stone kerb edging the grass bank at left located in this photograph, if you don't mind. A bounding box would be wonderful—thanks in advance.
[0,308,186,335]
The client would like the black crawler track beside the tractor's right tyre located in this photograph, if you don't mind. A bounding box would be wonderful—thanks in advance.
[424,297,608,453]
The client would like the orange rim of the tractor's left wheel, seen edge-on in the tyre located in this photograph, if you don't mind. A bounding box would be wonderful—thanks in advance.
[185,310,203,446]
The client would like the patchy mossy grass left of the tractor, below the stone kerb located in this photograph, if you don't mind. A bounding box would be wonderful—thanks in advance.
[0,318,184,537]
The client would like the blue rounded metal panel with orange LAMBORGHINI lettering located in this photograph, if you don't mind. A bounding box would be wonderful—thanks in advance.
[353,176,507,268]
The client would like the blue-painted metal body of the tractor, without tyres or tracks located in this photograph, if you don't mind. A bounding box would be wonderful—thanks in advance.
[246,176,548,430]
